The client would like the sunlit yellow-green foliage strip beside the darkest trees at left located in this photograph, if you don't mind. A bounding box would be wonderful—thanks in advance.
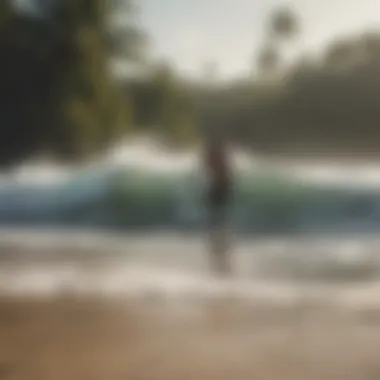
[49,0,132,159]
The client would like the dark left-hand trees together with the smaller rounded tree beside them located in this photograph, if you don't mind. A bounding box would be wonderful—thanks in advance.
[0,0,191,166]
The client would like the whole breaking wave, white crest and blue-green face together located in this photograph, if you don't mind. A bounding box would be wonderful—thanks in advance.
[0,138,380,235]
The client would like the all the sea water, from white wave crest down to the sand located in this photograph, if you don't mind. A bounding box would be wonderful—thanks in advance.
[0,139,380,307]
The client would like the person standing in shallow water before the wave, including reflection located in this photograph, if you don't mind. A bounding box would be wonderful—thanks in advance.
[205,138,232,275]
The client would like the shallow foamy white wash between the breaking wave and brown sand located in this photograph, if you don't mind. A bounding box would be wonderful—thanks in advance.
[0,230,380,307]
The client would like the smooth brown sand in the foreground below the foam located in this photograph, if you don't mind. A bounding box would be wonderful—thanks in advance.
[0,296,380,380]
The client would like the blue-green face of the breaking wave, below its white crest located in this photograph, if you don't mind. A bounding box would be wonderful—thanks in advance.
[0,168,380,234]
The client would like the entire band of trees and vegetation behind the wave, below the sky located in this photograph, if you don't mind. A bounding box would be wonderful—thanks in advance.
[0,0,380,166]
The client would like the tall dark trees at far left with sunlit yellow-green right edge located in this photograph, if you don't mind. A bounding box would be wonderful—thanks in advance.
[0,0,137,165]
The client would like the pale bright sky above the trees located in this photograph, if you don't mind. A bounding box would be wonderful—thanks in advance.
[139,0,380,77]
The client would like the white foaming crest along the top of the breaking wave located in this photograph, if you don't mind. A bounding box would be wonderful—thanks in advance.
[0,137,380,188]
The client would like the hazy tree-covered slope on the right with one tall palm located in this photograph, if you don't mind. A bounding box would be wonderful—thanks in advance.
[194,8,380,157]
